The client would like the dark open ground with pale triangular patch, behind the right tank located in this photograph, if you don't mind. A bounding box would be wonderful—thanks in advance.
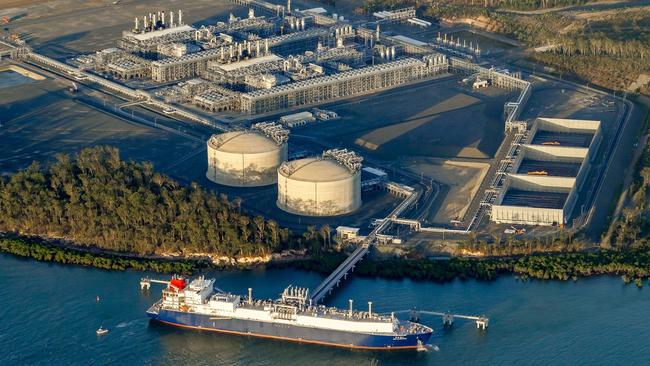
[304,79,510,160]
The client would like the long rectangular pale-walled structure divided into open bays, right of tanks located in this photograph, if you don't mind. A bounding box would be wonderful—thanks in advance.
[491,118,602,225]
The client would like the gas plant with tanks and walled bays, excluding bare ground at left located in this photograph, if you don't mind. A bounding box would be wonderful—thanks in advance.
[0,0,624,247]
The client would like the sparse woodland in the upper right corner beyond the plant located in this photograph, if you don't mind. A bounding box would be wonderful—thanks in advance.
[357,0,650,94]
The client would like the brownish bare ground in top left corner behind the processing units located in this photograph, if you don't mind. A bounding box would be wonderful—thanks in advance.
[0,0,247,59]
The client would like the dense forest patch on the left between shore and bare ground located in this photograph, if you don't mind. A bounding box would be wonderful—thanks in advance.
[0,147,295,257]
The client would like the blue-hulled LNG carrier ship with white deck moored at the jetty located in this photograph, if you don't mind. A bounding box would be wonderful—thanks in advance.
[147,277,433,349]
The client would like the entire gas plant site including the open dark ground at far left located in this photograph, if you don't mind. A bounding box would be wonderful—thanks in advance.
[0,0,629,250]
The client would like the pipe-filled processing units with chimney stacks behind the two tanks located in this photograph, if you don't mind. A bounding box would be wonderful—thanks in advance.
[67,2,449,115]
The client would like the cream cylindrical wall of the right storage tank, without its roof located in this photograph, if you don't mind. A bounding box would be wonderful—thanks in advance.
[277,172,361,216]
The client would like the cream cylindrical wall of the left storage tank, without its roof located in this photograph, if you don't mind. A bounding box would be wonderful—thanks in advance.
[206,143,288,187]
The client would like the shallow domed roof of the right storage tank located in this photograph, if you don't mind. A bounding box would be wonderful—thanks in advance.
[280,157,353,182]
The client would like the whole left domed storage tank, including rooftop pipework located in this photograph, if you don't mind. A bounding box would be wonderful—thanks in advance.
[206,123,289,187]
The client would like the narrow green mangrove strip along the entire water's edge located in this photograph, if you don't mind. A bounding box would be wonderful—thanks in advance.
[0,236,650,287]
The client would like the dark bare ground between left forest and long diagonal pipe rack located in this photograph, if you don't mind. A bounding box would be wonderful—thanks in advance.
[0,62,204,174]
